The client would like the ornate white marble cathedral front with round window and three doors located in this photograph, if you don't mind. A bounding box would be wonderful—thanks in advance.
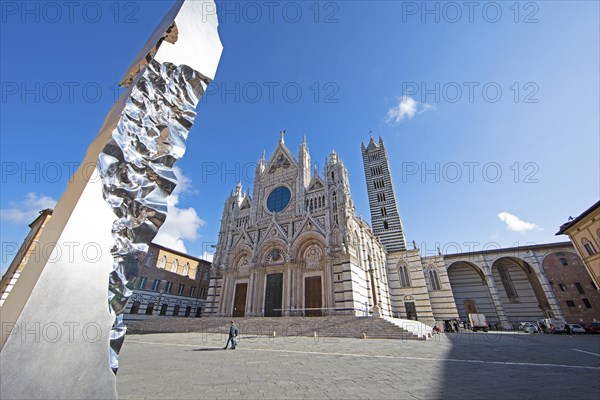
[207,134,393,317]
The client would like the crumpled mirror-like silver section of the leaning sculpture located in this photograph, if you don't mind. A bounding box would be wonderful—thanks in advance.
[97,60,211,373]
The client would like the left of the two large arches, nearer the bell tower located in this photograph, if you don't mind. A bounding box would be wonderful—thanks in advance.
[448,261,500,325]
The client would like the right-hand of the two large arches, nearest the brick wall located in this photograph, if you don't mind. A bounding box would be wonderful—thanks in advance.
[492,257,551,327]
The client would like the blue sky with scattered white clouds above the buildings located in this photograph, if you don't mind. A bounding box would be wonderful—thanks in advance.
[0,1,600,268]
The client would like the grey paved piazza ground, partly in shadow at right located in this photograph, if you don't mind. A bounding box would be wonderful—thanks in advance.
[117,332,600,400]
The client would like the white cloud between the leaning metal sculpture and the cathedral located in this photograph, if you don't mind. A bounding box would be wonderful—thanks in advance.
[153,167,206,253]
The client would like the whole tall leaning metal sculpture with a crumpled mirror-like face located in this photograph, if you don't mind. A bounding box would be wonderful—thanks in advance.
[0,0,222,399]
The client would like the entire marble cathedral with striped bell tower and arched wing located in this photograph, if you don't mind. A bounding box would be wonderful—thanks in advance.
[206,133,573,327]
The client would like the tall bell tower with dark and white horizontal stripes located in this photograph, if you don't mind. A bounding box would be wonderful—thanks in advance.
[361,136,406,253]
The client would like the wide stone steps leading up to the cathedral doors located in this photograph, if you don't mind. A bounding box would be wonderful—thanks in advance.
[126,316,427,340]
